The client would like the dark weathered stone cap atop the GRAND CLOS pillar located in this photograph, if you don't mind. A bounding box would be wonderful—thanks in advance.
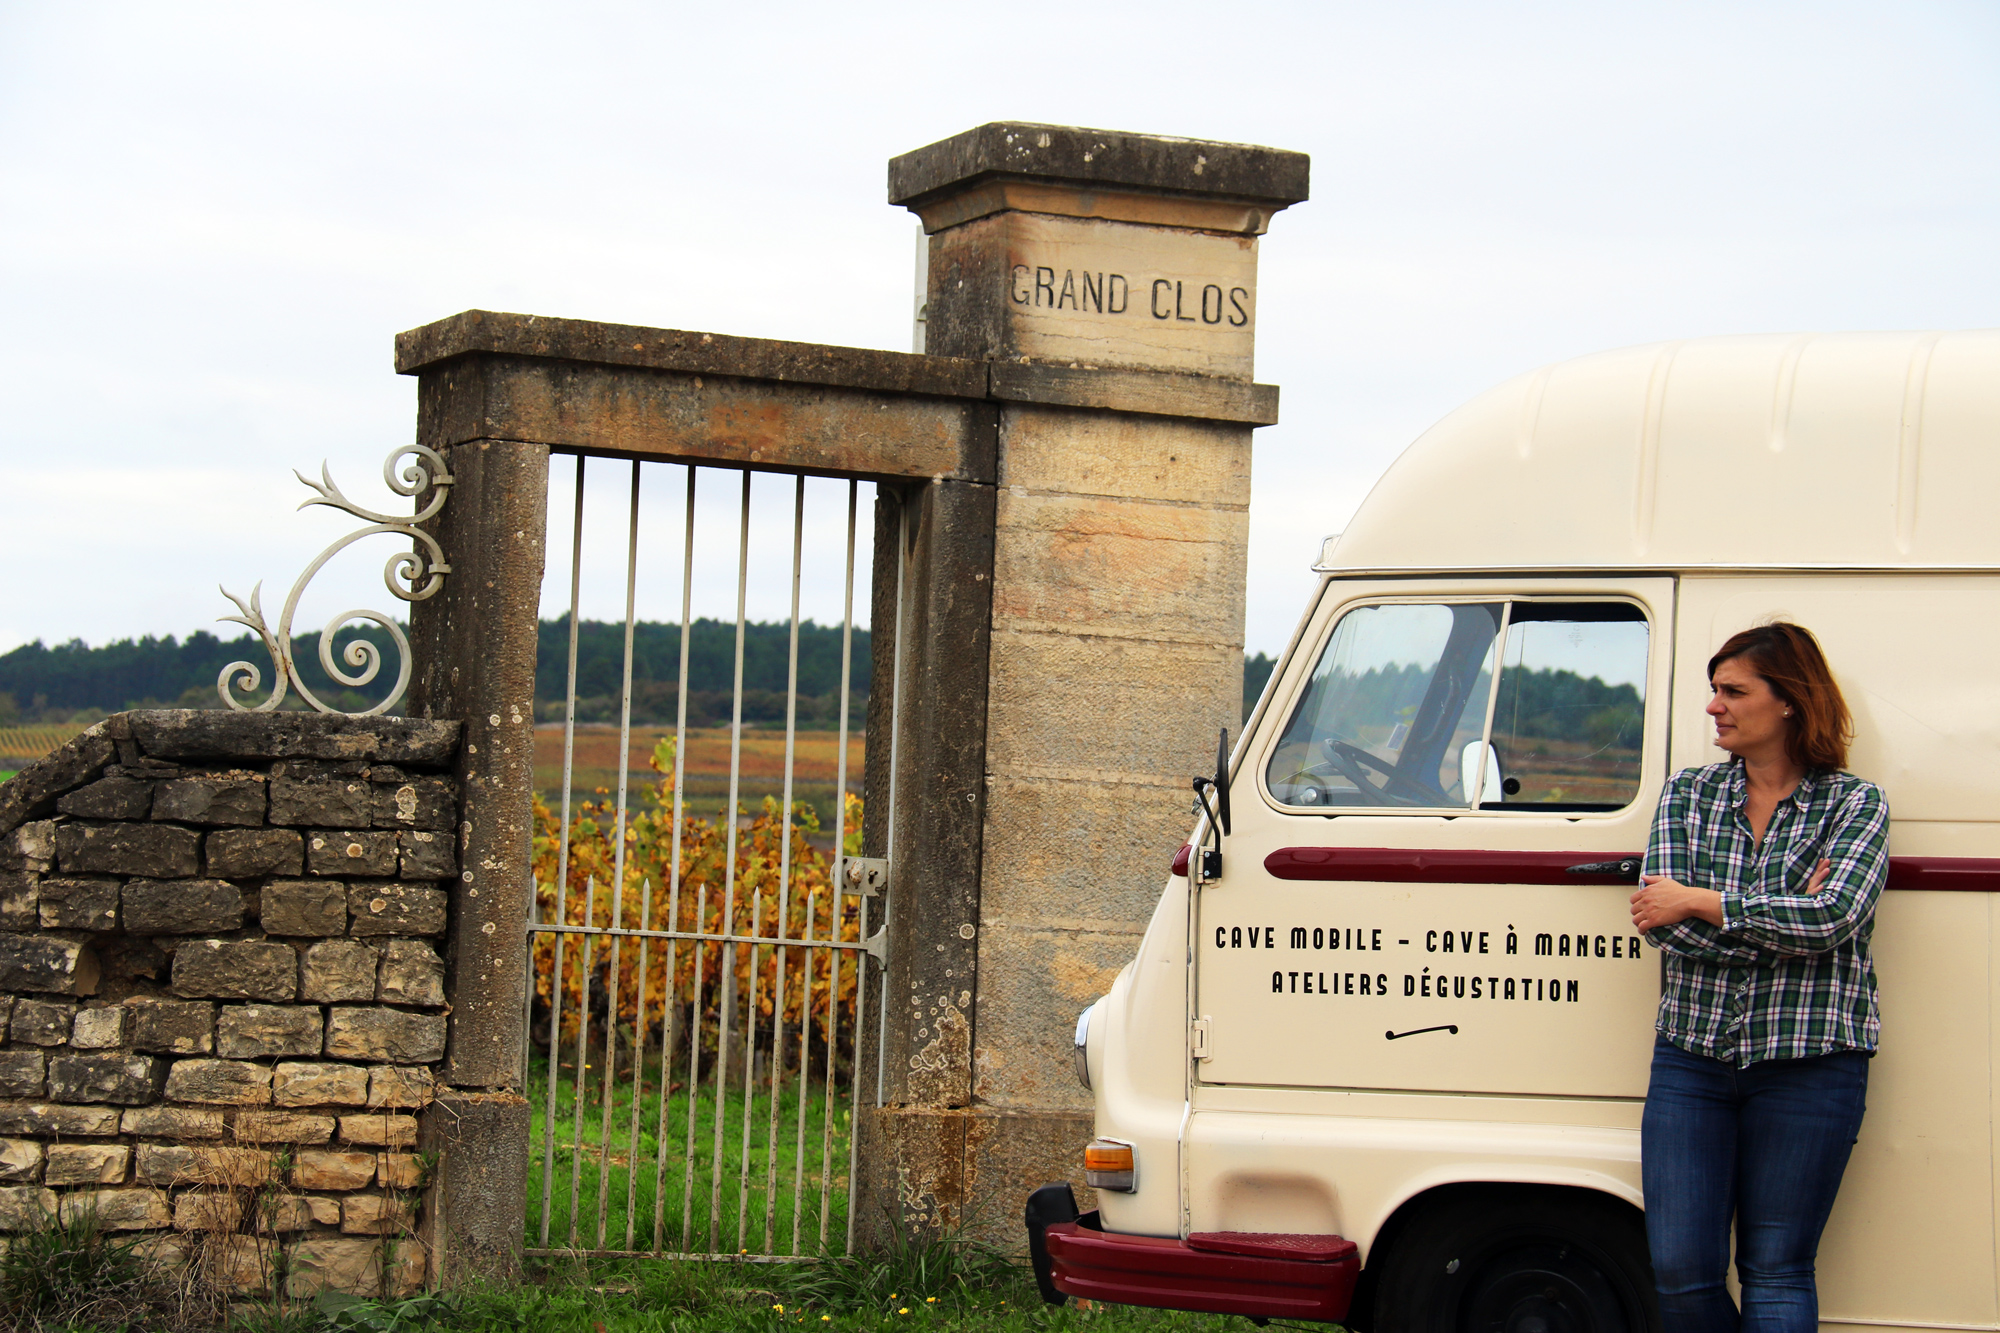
[888,120,1312,234]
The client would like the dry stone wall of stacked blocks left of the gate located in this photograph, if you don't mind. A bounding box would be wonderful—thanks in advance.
[0,711,460,1295]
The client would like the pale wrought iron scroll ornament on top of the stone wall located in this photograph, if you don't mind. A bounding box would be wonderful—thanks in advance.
[216,444,452,717]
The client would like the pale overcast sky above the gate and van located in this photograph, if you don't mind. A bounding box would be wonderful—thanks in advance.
[0,0,2000,652]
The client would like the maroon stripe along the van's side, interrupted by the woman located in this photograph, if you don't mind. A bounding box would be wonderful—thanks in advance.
[1264,847,2000,893]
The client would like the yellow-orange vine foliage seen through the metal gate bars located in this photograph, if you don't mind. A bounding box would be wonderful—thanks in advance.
[532,737,862,1063]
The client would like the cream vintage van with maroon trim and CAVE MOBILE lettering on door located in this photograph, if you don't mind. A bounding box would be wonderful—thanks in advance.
[1028,332,2000,1333]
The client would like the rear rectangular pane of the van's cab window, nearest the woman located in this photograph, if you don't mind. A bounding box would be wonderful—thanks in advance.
[1480,602,1646,811]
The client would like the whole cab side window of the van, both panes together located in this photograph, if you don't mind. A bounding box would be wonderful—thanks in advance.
[1264,600,1648,811]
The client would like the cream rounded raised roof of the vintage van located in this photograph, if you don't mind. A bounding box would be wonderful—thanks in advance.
[1316,330,2000,572]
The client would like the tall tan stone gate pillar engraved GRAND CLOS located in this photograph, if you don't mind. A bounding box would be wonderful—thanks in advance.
[856,124,1308,1249]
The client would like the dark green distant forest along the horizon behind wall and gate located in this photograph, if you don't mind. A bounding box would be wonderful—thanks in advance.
[0,616,1272,727]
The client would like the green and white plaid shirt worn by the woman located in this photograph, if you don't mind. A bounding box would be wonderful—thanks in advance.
[1646,759,1888,1067]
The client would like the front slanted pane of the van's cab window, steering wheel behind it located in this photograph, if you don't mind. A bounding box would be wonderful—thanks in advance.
[1264,602,1506,809]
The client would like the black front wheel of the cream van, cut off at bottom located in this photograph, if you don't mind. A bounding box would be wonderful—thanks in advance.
[1374,1189,1660,1333]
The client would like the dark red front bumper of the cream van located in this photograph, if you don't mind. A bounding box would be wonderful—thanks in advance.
[1044,1213,1362,1323]
